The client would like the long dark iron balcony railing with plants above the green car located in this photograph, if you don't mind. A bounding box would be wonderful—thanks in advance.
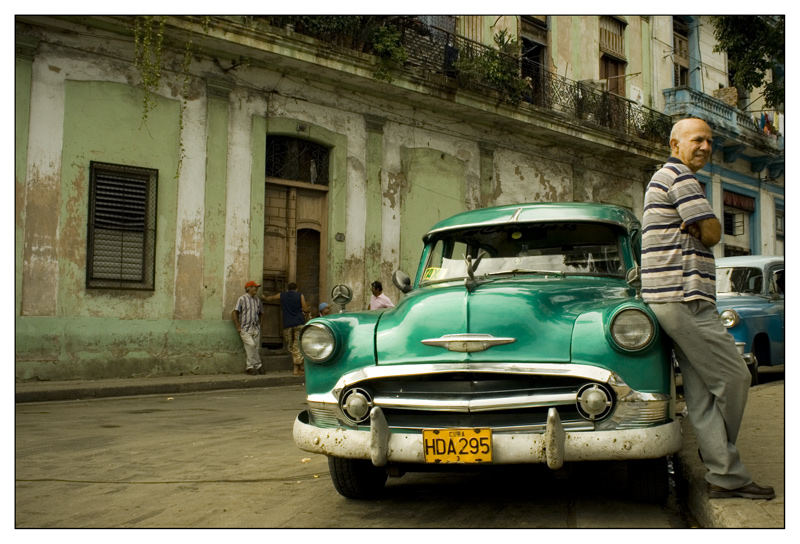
[403,27,672,144]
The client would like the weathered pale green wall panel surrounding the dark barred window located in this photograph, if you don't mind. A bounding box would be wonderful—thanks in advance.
[57,81,180,319]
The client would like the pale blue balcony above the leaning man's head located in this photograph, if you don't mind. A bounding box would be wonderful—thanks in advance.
[664,87,784,156]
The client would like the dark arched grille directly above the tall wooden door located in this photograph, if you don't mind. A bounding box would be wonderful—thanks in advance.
[266,136,330,185]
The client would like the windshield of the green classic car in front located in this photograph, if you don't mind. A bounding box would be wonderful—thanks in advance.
[421,222,625,285]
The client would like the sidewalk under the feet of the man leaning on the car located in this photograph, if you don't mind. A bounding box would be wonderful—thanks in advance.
[677,380,786,528]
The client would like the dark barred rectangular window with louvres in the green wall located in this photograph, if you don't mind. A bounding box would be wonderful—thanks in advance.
[86,161,158,290]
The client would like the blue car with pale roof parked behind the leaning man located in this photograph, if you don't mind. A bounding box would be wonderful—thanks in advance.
[716,255,785,385]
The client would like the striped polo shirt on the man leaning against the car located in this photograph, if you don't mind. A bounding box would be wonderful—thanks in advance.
[642,157,716,303]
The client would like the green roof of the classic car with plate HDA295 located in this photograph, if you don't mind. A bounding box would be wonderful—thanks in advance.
[423,202,640,241]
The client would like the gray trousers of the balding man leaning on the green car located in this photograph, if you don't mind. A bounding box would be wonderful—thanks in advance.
[649,300,753,489]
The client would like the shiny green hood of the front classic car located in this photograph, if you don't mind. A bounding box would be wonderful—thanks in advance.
[375,277,632,365]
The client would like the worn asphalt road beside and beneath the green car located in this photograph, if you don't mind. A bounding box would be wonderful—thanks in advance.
[15,386,693,529]
